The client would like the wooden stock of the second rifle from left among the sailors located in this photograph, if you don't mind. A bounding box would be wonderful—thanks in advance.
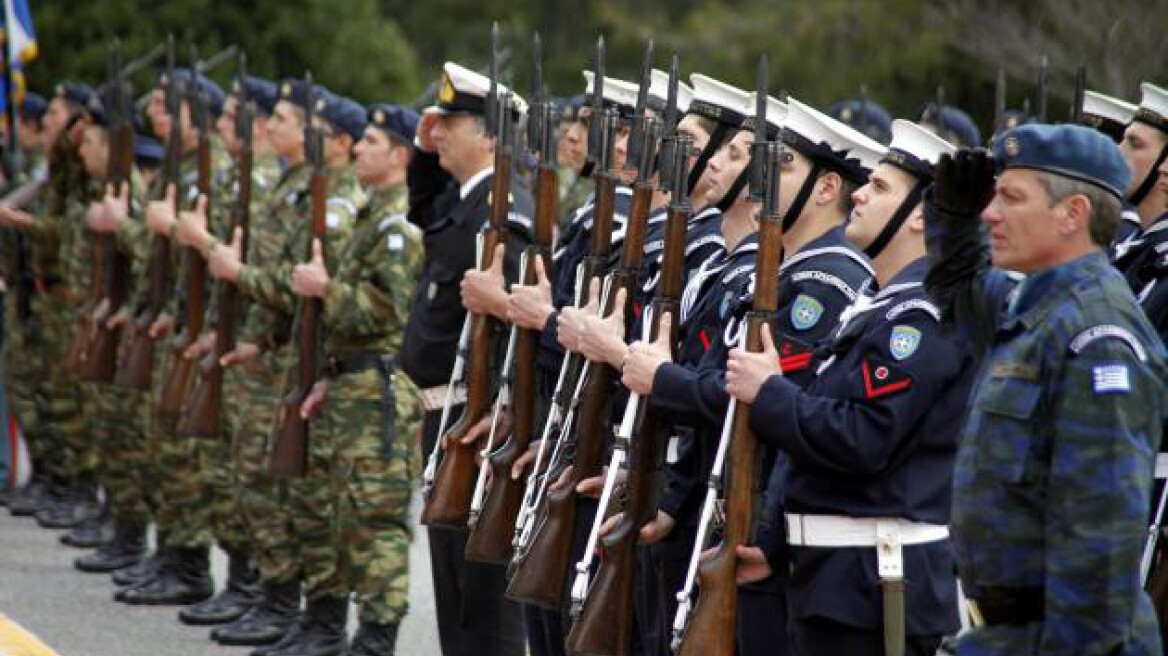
[466,166,559,555]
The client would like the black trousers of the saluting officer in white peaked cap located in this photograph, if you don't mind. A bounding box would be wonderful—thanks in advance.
[422,409,524,656]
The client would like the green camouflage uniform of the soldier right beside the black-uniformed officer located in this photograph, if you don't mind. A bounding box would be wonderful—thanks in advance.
[327,180,422,623]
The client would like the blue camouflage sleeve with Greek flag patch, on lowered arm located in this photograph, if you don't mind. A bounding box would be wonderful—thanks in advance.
[1036,339,1163,656]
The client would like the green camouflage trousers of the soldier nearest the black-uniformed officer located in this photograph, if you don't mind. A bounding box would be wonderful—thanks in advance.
[331,364,422,623]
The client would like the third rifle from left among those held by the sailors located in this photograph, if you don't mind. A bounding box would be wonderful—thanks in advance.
[507,36,619,609]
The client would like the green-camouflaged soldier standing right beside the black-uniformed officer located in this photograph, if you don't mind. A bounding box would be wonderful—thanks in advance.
[290,99,422,656]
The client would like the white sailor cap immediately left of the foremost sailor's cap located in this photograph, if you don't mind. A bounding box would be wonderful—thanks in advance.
[783,98,888,179]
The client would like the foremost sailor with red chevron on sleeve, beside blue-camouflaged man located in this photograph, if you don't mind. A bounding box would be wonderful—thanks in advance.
[726,120,973,656]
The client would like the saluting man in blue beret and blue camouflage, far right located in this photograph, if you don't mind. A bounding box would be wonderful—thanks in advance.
[925,125,1168,655]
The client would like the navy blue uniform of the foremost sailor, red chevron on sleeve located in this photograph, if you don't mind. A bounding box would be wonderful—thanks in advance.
[751,258,974,654]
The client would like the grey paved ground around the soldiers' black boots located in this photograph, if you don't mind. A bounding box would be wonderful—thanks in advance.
[0,494,439,656]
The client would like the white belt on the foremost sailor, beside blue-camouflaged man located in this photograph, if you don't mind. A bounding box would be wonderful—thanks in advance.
[787,512,948,547]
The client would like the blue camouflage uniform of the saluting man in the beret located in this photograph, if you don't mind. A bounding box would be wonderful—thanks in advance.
[926,206,1168,656]
